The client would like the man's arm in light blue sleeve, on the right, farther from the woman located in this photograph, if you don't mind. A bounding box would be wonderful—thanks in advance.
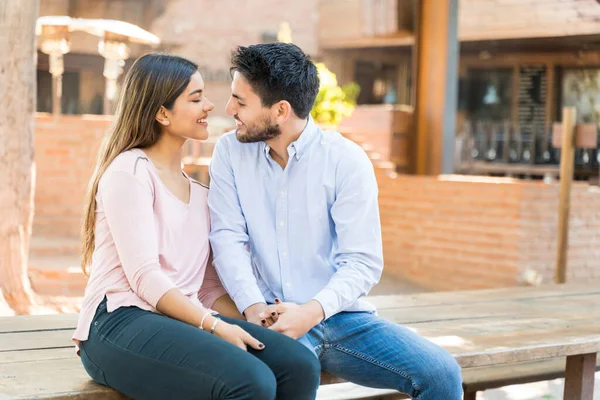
[314,144,383,318]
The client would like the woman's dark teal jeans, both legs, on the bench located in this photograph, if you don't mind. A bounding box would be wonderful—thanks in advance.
[80,300,320,400]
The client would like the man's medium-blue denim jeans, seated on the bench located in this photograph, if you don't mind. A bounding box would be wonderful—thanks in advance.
[299,312,463,400]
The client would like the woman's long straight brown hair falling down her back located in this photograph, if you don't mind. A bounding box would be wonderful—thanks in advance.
[81,53,198,274]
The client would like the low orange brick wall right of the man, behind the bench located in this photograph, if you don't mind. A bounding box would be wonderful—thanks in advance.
[377,172,600,290]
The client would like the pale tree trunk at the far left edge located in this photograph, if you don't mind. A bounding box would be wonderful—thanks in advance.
[0,0,39,314]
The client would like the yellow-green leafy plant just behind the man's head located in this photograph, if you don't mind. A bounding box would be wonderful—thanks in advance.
[310,63,360,125]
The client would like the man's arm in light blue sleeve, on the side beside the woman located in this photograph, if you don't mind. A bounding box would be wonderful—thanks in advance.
[208,138,266,322]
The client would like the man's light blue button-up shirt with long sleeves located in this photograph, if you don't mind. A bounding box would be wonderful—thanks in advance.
[208,118,383,318]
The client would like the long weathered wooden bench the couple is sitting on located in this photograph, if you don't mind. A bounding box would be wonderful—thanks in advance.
[0,284,600,400]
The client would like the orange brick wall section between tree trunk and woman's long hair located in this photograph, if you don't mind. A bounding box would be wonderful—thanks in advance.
[33,114,111,237]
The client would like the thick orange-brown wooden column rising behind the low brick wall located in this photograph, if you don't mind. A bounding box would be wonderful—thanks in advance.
[412,0,459,175]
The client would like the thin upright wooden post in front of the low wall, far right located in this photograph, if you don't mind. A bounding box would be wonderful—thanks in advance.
[554,107,577,283]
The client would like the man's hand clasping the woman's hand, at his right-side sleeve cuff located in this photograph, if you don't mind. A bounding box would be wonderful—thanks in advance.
[269,300,325,339]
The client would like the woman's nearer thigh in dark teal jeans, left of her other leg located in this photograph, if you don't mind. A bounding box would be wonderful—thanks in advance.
[81,305,276,400]
